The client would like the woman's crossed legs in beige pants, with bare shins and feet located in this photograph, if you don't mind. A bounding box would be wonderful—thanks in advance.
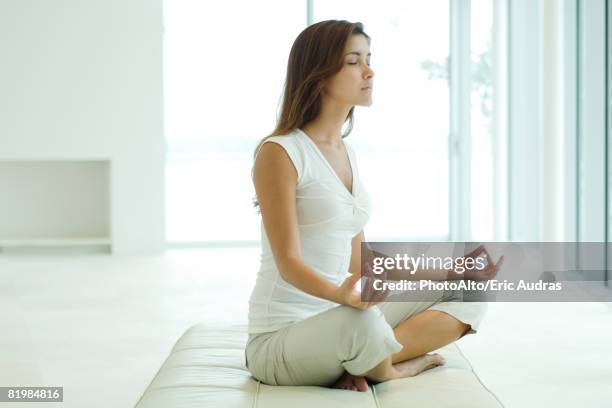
[245,297,482,390]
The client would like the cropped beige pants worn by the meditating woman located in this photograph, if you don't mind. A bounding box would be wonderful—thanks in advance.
[245,292,487,386]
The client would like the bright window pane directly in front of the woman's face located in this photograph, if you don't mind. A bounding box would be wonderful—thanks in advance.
[314,0,449,240]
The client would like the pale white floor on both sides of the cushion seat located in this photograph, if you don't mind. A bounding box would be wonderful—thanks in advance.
[0,247,612,408]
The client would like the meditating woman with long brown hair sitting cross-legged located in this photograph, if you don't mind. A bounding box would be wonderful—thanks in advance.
[245,20,497,391]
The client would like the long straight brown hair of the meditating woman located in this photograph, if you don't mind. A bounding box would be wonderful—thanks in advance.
[253,20,371,207]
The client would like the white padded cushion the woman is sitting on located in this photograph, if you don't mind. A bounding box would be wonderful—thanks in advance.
[136,324,502,408]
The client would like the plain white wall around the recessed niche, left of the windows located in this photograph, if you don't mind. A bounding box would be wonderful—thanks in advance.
[0,0,165,253]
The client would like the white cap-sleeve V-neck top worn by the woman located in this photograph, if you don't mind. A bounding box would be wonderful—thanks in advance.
[249,129,372,333]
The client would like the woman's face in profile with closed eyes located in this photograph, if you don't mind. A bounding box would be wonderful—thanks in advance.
[324,34,374,107]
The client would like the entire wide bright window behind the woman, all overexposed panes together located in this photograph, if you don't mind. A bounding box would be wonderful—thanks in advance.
[164,0,504,246]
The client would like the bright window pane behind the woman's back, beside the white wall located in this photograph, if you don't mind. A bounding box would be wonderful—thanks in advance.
[164,0,306,243]
